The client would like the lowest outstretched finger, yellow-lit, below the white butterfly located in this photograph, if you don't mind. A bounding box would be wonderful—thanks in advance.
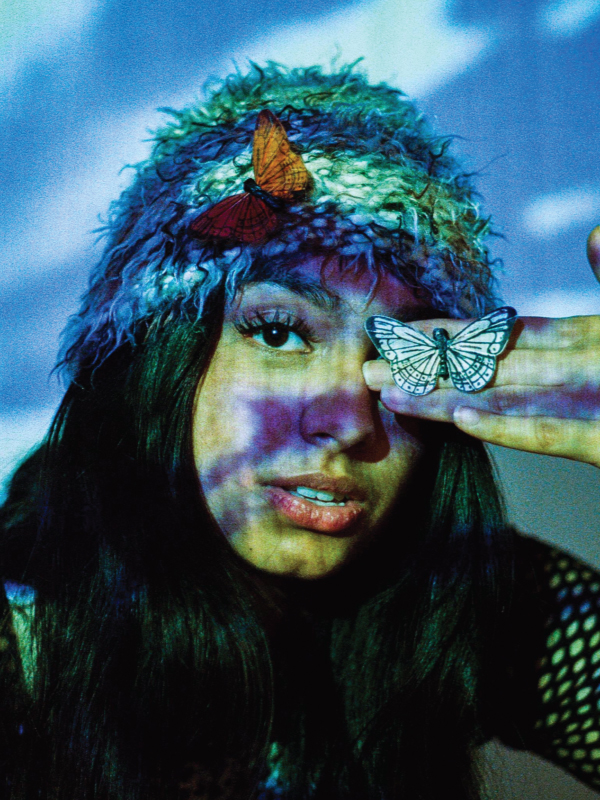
[454,406,600,466]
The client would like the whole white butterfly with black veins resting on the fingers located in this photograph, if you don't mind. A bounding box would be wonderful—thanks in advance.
[365,306,517,397]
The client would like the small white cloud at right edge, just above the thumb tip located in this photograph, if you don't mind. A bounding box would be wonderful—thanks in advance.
[522,187,600,239]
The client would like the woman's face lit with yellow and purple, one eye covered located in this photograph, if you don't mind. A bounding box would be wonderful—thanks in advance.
[193,258,423,579]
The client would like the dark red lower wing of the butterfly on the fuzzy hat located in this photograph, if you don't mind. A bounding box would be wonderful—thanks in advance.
[190,192,277,244]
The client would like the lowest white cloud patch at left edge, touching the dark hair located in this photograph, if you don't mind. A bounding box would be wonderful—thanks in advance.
[0,406,56,502]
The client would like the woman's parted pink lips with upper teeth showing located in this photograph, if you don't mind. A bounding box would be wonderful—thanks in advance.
[265,473,364,534]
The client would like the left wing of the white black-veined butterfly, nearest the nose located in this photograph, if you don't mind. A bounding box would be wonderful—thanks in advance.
[365,316,440,397]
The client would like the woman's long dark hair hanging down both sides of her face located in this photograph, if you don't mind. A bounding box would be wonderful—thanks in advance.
[0,301,510,800]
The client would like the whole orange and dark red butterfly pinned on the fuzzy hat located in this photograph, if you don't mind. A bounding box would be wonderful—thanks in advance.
[190,111,312,244]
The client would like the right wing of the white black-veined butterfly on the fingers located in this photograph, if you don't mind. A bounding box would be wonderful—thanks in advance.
[446,306,517,392]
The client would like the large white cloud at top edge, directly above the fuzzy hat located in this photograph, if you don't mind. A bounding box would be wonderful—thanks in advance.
[238,0,495,97]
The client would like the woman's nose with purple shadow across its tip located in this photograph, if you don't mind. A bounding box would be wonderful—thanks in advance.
[300,353,377,451]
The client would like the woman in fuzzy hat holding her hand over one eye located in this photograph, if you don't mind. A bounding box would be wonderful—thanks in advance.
[0,66,600,800]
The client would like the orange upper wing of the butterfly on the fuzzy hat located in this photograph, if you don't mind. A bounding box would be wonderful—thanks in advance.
[252,110,311,200]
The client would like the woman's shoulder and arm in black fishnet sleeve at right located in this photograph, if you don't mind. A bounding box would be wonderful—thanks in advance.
[500,536,600,788]
